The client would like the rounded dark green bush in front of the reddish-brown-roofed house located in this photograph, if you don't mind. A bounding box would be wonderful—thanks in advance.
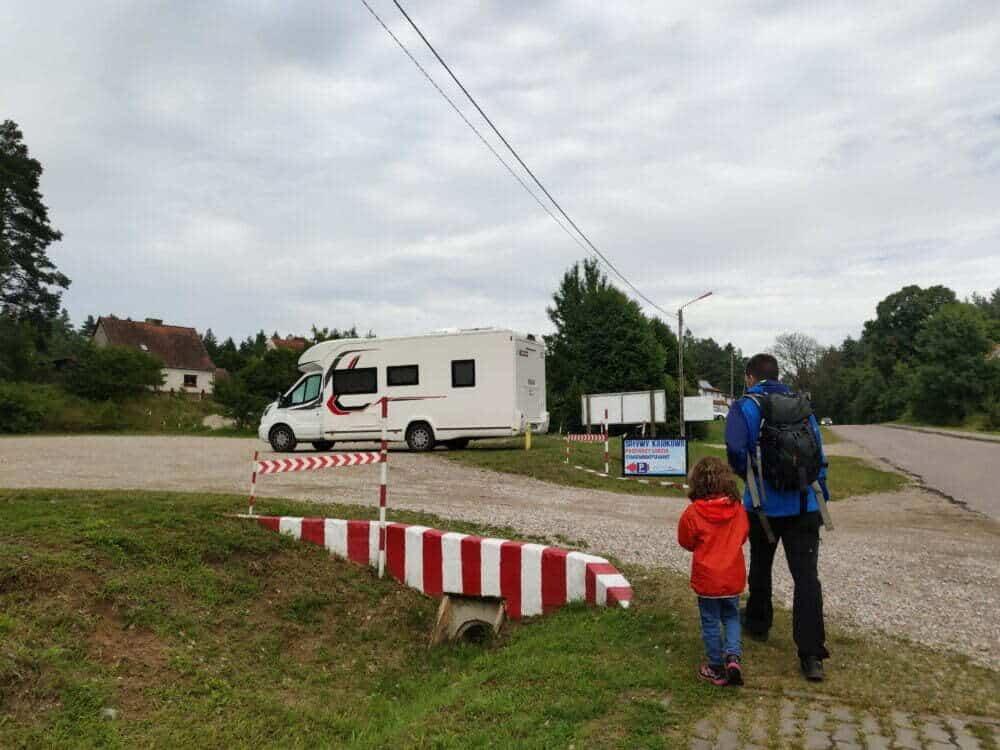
[65,344,163,401]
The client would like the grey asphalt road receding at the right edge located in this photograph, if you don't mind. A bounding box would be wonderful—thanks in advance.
[834,425,1000,520]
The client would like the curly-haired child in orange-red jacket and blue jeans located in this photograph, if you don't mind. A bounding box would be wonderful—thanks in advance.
[677,456,750,685]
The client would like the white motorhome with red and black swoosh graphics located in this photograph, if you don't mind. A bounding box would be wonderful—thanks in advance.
[258,328,549,451]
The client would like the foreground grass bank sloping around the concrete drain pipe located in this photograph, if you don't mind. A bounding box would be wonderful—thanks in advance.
[0,490,1000,748]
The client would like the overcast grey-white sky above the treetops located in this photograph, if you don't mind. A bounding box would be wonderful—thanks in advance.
[0,0,1000,350]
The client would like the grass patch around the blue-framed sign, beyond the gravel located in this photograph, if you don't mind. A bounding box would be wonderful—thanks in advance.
[441,432,909,500]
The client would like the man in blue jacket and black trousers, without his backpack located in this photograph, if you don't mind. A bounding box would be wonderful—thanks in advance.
[726,354,829,682]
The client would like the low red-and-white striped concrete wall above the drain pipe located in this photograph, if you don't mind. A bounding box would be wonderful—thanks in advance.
[241,515,632,619]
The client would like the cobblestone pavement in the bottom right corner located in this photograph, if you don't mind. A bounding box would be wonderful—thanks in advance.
[688,691,1000,750]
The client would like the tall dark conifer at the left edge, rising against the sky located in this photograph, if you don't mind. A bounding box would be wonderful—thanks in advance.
[0,120,69,328]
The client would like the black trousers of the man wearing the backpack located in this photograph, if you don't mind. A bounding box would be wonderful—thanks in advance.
[745,511,829,659]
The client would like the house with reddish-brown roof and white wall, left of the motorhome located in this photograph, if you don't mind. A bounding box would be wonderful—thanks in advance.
[92,315,216,393]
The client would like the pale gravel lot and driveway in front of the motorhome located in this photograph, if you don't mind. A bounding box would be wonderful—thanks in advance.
[0,428,1000,664]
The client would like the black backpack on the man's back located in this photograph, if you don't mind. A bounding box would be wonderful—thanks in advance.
[747,393,822,496]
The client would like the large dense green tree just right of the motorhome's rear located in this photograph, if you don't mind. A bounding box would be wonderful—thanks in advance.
[545,260,666,427]
